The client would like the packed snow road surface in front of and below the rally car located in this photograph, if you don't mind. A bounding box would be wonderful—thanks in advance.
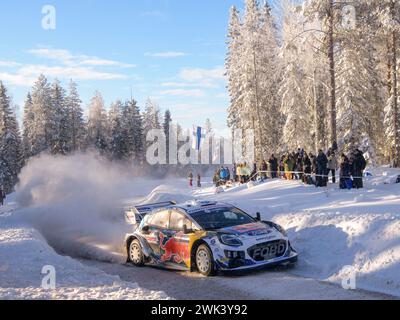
[81,260,393,300]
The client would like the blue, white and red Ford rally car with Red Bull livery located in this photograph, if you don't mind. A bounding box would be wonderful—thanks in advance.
[124,201,298,276]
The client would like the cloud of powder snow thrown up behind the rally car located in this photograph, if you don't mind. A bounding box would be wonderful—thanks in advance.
[16,154,139,261]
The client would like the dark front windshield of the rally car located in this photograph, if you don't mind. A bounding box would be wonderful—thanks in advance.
[191,207,255,230]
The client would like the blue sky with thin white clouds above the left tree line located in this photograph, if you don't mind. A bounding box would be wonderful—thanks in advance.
[0,0,278,129]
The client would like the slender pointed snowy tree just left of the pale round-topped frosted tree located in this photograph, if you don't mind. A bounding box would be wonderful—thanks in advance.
[66,80,86,152]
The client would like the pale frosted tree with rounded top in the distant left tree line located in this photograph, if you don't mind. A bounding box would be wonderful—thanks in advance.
[87,91,107,154]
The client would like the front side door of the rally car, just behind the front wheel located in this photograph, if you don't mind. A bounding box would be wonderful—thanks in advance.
[164,210,192,268]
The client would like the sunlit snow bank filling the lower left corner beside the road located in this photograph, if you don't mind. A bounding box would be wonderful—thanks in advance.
[0,217,168,300]
